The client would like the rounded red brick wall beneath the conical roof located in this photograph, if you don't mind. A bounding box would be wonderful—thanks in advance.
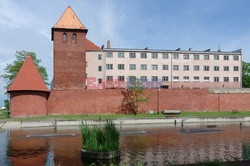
[10,91,48,118]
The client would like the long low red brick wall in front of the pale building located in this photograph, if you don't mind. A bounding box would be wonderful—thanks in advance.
[48,89,250,114]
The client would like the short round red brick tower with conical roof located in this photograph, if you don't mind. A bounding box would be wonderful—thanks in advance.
[7,56,50,117]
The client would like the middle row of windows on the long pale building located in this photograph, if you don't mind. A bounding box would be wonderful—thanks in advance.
[98,64,239,71]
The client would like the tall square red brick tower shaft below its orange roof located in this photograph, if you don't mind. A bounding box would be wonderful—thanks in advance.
[53,29,86,90]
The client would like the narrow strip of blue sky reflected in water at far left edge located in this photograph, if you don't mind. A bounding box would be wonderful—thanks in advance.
[0,130,10,165]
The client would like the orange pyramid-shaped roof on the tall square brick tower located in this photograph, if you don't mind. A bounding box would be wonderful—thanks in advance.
[53,6,87,30]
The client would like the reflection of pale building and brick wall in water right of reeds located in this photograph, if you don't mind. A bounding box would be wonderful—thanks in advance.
[120,128,250,165]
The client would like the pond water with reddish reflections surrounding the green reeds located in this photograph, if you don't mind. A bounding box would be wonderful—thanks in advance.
[0,124,250,166]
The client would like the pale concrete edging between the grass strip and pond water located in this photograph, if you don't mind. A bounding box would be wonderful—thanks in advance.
[0,117,250,130]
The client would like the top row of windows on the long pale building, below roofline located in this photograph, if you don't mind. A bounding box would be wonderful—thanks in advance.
[102,52,239,61]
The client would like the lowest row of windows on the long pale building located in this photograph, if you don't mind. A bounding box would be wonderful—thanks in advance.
[102,76,239,83]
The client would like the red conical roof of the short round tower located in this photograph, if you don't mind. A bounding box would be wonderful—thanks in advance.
[8,56,49,92]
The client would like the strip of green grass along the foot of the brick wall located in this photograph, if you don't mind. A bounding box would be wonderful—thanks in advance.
[0,111,250,121]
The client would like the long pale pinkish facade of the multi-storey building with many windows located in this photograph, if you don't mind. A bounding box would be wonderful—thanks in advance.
[86,48,242,89]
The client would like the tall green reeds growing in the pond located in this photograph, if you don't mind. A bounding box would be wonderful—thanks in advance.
[81,120,120,152]
